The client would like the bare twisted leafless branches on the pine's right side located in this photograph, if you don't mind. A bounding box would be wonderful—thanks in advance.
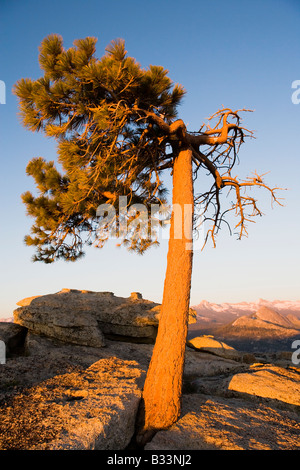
[186,108,283,247]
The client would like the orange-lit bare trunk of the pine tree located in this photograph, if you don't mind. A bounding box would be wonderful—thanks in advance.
[140,149,194,442]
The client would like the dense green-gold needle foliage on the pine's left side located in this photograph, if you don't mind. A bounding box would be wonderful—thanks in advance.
[14,35,185,263]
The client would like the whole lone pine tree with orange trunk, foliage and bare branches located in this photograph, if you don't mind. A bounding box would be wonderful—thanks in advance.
[14,35,278,442]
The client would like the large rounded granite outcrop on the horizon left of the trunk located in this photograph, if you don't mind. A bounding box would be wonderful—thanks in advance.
[14,289,195,347]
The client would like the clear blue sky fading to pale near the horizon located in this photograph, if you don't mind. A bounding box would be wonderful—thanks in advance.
[0,0,300,317]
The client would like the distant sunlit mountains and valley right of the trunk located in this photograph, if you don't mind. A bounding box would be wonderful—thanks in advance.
[189,299,300,352]
